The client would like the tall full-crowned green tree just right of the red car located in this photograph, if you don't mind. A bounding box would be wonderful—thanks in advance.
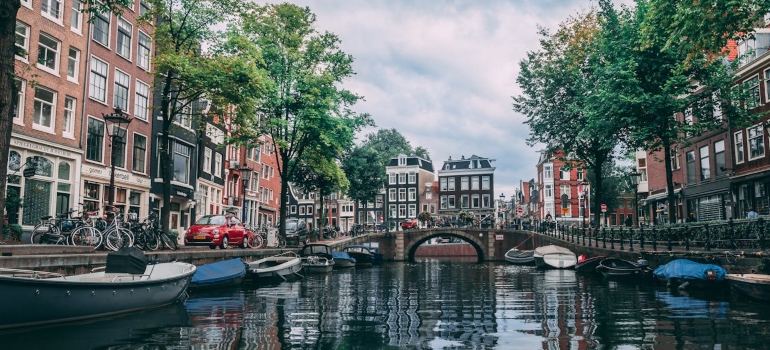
[237,3,371,235]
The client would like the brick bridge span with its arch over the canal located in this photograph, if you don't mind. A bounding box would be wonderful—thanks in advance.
[403,229,491,261]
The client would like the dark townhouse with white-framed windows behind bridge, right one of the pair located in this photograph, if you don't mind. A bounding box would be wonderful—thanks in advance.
[438,155,497,224]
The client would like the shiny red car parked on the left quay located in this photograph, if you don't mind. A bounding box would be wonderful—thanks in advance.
[184,215,248,249]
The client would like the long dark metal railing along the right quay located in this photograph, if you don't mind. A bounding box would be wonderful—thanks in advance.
[528,218,770,251]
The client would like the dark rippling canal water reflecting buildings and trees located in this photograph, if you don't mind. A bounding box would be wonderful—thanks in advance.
[0,259,770,350]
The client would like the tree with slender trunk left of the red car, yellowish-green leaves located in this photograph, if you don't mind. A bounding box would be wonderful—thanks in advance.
[146,0,268,235]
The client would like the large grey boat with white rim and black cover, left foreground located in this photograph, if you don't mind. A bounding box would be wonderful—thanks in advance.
[0,248,196,328]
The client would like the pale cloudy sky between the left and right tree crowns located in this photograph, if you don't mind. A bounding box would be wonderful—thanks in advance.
[288,0,628,199]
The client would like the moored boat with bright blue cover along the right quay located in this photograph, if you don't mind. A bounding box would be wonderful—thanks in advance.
[652,259,727,288]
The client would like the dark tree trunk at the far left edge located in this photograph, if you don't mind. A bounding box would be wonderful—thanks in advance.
[0,0,21,232]
